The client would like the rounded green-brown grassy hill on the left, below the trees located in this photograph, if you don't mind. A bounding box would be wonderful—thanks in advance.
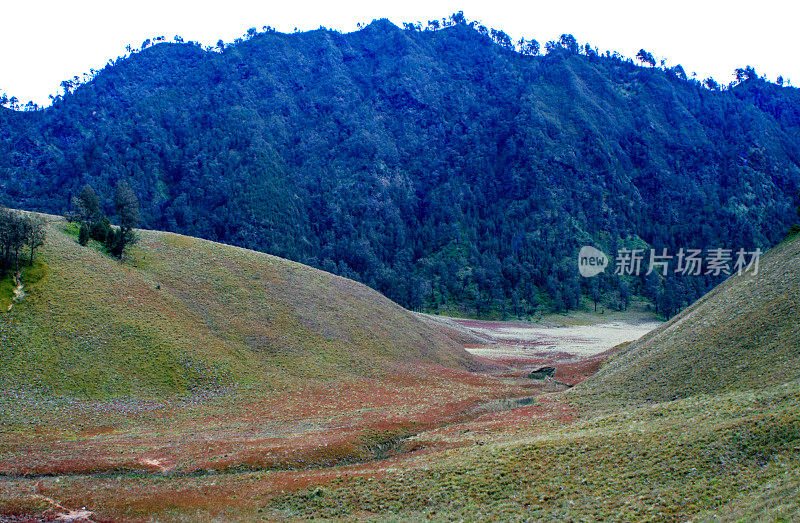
[0,218,472,398]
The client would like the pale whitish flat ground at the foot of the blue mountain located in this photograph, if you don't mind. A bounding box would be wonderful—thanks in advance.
[467,321,661,358]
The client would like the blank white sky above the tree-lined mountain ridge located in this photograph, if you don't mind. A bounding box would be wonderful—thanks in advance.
[0,0,800,105]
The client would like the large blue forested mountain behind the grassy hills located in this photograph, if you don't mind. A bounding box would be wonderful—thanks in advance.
[0,20,800,317]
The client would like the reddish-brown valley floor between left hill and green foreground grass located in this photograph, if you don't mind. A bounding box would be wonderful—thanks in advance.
[0,336,644,520]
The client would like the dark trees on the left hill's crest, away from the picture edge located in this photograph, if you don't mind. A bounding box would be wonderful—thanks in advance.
[65,180,139,258]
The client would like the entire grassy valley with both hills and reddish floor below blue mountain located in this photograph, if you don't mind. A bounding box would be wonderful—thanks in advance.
[0,217,800,521]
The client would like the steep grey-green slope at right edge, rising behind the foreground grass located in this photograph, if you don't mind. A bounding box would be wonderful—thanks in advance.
[574,237,800,403]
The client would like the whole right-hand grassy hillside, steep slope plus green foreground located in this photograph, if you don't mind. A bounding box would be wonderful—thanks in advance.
[266,238,800,521]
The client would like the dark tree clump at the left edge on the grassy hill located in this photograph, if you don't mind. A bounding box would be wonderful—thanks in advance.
[0,207,47,279]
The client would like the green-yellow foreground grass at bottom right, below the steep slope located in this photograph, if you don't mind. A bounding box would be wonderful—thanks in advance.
[270,376,800,520]
